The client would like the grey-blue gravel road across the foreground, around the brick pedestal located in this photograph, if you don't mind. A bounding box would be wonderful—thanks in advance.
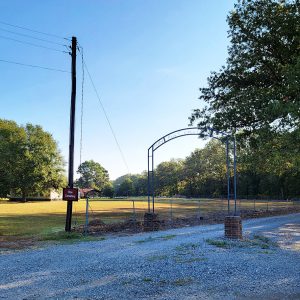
[0,214,300,300]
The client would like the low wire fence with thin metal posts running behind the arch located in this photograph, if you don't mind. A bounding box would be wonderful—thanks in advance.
[73,197,300,232]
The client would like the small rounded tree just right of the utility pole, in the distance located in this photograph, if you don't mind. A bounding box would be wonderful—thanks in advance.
[75,160,109,191]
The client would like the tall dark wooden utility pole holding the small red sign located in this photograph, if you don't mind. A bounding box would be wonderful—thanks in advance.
[65,36,77,231]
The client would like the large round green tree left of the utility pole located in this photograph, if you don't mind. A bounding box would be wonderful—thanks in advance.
[0,120,65,200]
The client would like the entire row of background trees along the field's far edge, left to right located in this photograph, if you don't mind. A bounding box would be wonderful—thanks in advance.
[0,120,300,199]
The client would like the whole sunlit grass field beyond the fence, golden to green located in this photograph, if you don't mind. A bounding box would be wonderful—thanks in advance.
[0,197,294,238]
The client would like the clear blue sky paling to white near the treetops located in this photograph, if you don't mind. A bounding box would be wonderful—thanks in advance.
[0,0,234,179]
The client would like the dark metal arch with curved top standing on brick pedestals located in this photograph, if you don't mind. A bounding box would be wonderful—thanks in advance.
[147,127,237,215]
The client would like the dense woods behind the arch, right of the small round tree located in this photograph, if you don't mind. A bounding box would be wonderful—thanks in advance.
[113,132,300,199]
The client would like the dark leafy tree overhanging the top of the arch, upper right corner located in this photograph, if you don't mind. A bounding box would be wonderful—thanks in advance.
[190,0,300,136]
